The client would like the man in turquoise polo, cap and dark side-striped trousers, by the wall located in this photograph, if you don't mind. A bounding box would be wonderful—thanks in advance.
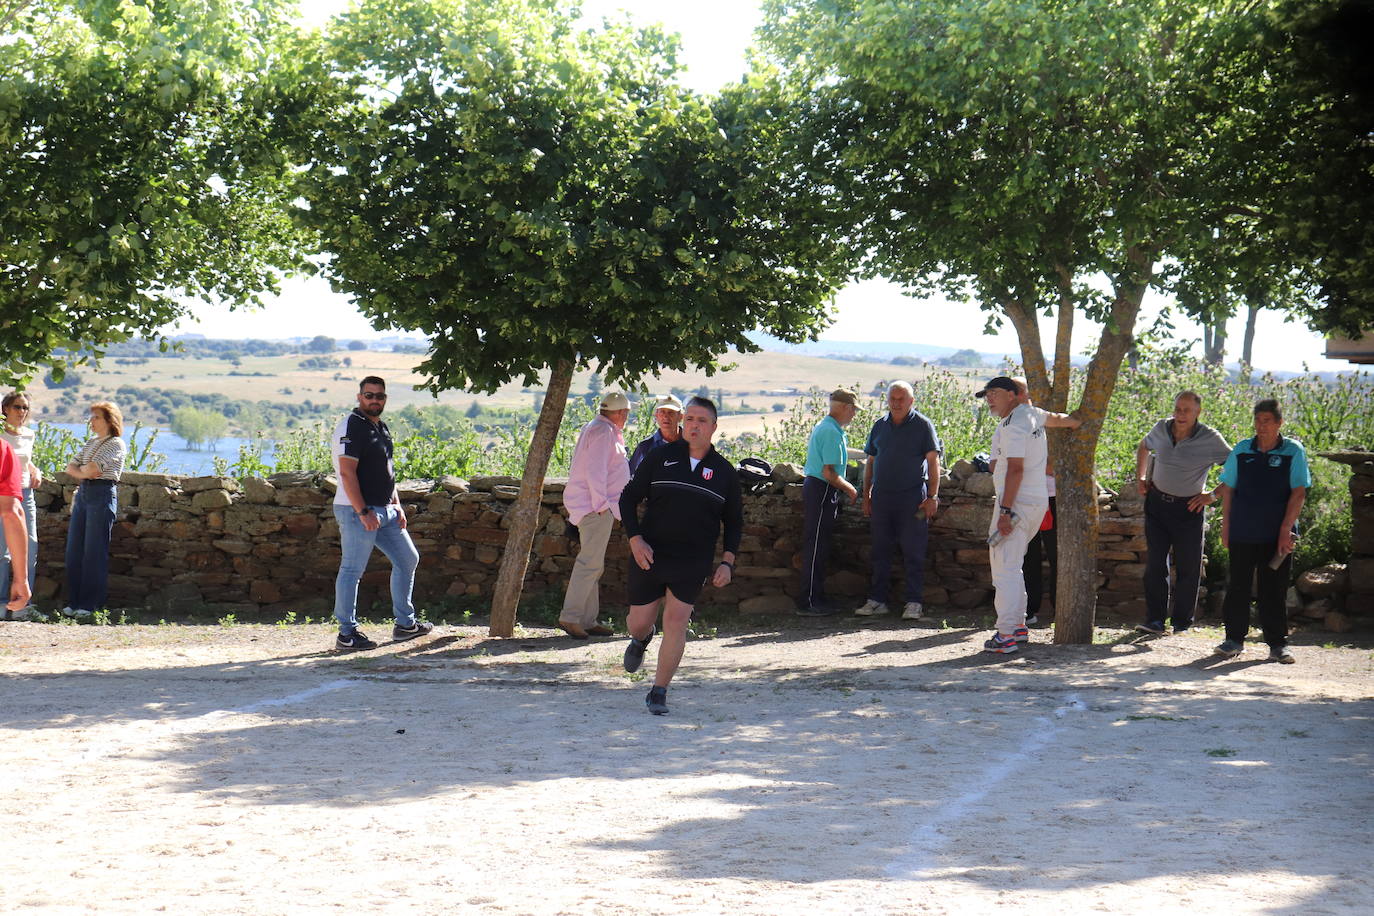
[797,389,859,617]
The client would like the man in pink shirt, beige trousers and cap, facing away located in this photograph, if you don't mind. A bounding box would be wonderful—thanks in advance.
[558,391,629,640]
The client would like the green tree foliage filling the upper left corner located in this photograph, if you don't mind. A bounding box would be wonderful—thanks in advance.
[0,0,301,385]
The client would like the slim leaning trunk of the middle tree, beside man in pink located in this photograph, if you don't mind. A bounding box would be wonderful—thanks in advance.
[486,360,573,637]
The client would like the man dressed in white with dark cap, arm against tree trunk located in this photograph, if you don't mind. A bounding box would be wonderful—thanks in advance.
[977,375,1050,654]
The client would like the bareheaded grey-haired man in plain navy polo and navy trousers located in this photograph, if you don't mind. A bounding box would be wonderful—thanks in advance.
[855,382,940,621]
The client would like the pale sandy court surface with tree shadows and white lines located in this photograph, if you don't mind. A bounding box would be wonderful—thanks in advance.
[0,622,1374,916]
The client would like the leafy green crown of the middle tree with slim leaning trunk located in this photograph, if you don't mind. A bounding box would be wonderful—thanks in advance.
[297,0,841,391]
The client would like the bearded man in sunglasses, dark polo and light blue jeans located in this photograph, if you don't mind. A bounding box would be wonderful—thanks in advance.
[334,375,434,652]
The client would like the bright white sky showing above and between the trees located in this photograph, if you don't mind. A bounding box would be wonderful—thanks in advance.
[164,0,1351,371]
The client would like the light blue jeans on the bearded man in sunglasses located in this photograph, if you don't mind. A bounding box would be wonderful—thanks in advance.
[334,505,420,636]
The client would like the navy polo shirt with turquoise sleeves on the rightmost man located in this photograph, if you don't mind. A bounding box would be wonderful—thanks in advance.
[1221,435,1312,544]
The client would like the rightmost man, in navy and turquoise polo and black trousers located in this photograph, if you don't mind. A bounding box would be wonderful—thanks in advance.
[1216,400,1312,665]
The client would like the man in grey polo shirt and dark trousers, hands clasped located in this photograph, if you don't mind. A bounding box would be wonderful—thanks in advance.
[1135,391,1231,633]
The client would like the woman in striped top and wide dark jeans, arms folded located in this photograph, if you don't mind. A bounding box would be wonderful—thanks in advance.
[62,401,125,618]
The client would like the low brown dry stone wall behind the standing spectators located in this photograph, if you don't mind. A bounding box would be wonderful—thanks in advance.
[24,461,1145,619]
